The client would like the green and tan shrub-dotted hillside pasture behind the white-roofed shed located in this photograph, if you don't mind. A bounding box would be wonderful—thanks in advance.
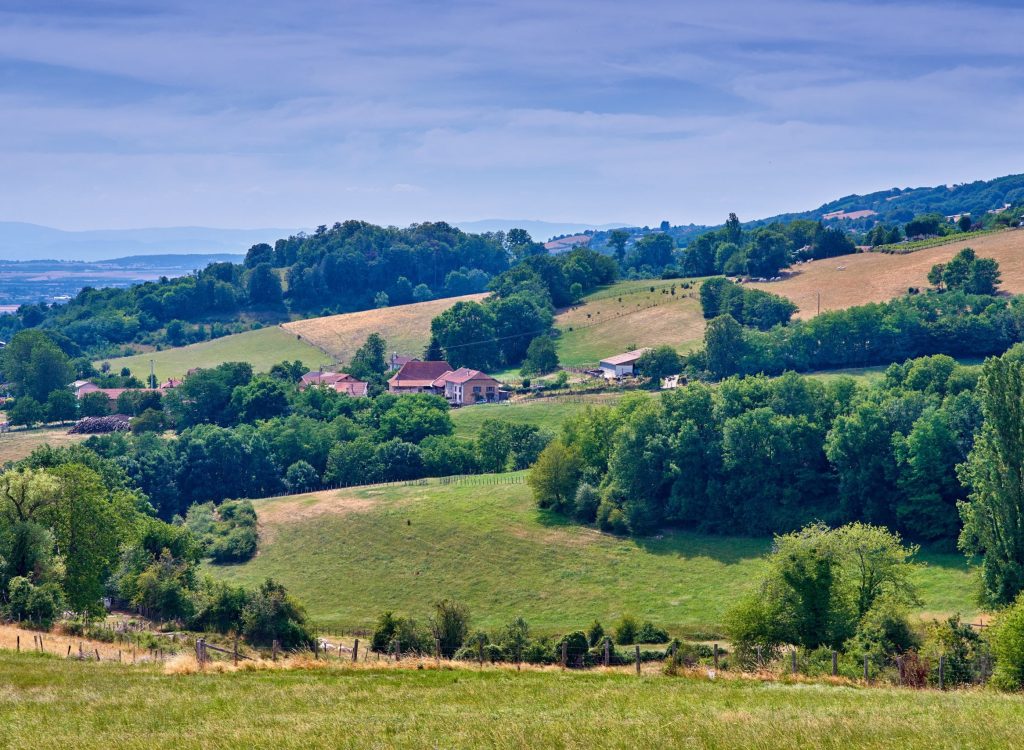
[555,279,705,366]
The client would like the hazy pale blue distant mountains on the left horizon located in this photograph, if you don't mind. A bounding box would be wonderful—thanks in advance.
[0,221,296,261]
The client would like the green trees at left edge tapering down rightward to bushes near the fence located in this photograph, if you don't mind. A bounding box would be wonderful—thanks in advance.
[0,446,310,645]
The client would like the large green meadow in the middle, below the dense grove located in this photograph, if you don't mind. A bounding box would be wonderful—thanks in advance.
[210,475,974,633]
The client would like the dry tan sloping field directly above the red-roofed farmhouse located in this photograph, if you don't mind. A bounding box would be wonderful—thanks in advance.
[283,294,486,363]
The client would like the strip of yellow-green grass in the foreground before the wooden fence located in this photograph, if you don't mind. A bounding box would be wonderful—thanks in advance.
[0,653,1024,750]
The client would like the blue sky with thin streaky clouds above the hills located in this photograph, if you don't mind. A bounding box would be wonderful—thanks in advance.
[0,0,1024,230]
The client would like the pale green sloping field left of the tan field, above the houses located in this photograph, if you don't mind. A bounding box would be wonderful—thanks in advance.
[97,326,331,381]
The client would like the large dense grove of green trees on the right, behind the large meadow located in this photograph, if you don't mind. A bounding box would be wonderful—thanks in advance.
[529,351,983,547]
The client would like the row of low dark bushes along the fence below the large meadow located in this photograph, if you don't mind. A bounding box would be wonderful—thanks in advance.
[370,599,678,667]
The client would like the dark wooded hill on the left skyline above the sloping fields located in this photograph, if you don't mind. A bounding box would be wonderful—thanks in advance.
[0,221,520,357]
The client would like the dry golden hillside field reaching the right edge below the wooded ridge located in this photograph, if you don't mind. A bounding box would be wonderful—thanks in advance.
[751,230,1024,318]
